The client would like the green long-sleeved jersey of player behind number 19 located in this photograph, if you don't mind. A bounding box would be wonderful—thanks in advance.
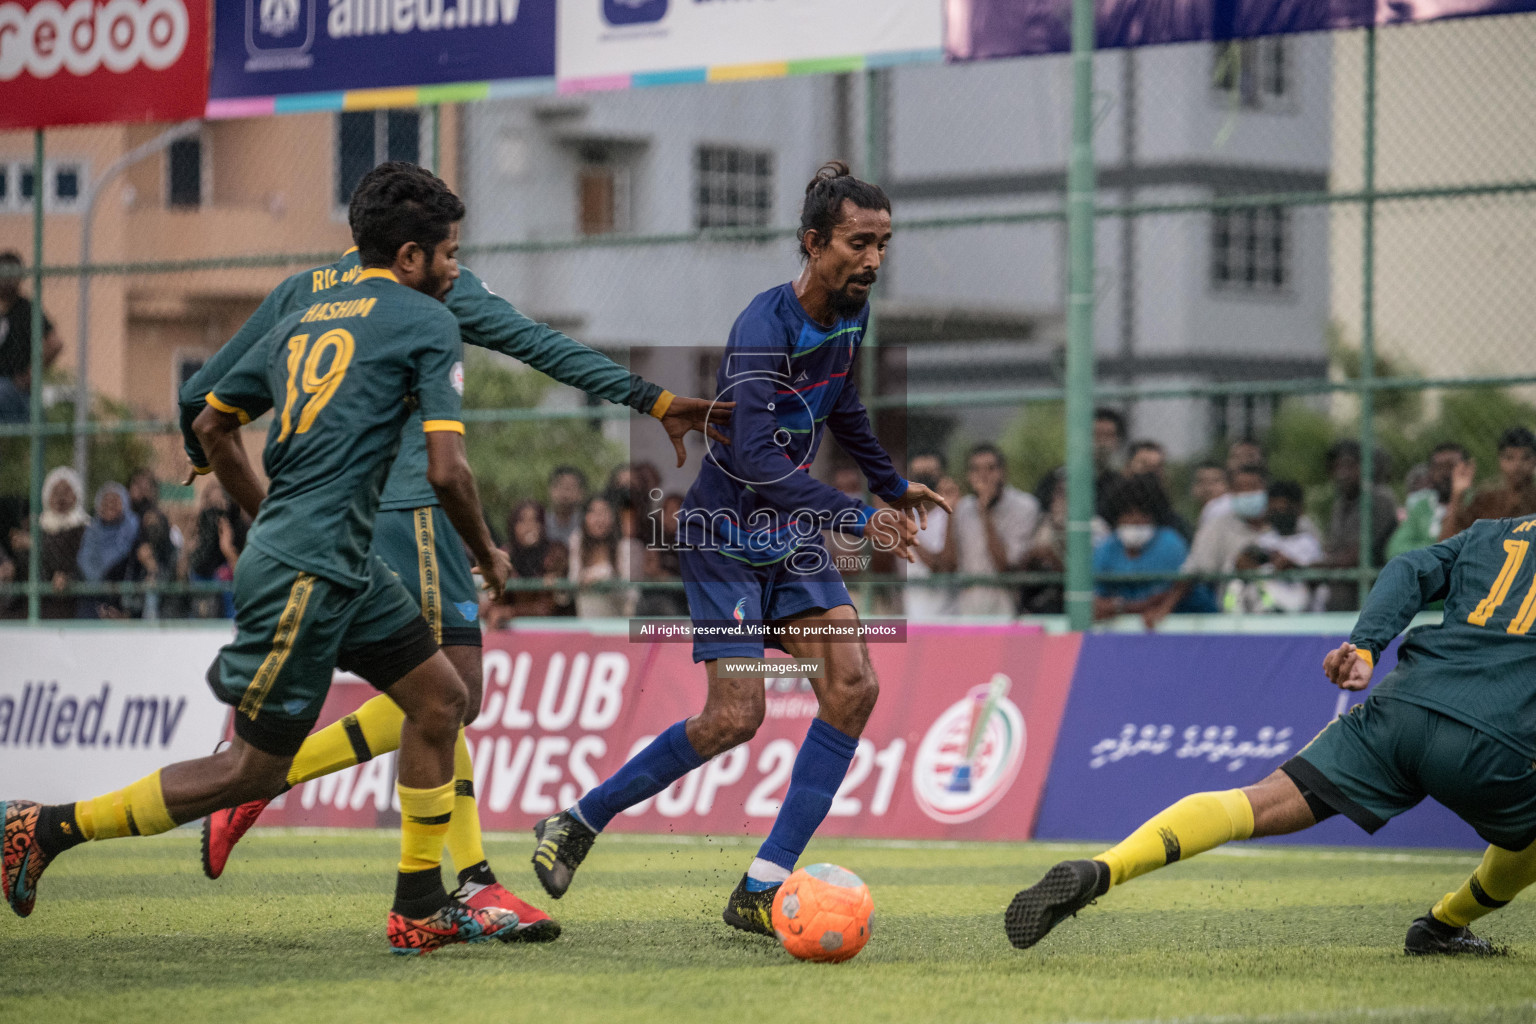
[180,249,662,508]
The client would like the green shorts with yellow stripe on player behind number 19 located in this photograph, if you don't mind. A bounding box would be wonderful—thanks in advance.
[373,505,481,646]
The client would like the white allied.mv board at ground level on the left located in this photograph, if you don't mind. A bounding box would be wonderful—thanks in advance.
[0,629,229,803]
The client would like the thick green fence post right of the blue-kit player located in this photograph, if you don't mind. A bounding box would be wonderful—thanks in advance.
[1066,0,1097,629]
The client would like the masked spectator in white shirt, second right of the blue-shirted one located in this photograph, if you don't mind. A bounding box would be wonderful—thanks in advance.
[1221,481,1327,614]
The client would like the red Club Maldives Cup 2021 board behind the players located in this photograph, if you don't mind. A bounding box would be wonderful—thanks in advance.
[261,626,1080,840]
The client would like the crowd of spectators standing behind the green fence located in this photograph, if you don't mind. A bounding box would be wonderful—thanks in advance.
[0,408,1536,628]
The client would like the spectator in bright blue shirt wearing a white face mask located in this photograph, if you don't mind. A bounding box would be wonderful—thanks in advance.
[1094,474,1189,619]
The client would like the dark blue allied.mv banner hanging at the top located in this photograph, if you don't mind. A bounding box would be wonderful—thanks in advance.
[207,0,554,102]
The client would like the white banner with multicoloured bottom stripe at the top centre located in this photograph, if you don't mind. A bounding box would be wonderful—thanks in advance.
[559,0,942,89]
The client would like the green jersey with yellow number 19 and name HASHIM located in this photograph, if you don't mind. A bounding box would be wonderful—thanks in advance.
[207,270,464,588]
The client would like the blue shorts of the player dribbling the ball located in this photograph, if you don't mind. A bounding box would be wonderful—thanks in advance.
[677,537,854,663]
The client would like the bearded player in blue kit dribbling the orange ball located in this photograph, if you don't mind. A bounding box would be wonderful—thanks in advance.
[533,163,949,935]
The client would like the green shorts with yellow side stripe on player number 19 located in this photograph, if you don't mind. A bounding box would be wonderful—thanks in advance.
[207,548,438,755]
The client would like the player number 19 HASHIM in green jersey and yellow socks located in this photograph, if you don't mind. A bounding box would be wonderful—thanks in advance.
[0,167,518,955]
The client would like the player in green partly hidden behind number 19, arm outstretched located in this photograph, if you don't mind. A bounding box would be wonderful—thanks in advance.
[180,161,731,941]
